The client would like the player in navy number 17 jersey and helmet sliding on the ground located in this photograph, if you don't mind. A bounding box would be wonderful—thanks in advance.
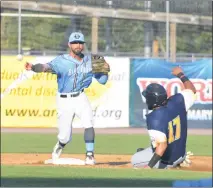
[131,67,196,168]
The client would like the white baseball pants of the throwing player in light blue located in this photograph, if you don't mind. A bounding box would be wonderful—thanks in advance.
[57,92,94,144]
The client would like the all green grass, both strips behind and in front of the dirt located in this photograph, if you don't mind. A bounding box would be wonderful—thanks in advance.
[1,133,212,187]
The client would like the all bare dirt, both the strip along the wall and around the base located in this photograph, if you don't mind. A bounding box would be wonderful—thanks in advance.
[1,128,212,172]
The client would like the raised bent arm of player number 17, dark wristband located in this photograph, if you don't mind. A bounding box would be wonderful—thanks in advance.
[172,67,196,111]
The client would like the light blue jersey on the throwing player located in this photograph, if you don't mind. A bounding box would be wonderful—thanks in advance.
[48,54,108,93]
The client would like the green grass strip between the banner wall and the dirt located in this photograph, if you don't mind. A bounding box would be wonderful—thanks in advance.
[1,133,212,156]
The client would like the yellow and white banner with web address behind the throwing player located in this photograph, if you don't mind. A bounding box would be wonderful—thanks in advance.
[1,56,129,128]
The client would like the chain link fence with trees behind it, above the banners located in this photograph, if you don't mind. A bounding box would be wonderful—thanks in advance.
[1,0,212,61]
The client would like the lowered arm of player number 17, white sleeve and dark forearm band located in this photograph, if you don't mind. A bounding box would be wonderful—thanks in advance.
[148,130,168,168]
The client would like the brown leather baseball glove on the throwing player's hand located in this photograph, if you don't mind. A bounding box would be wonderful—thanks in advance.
[92,55,110,74]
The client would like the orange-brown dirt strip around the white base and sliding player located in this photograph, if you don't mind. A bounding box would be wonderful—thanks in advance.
[1,153,212,172]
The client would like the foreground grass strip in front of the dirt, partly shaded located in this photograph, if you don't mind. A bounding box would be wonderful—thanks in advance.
[1,166,212,187]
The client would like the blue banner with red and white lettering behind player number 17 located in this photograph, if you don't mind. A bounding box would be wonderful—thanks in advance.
[129,59,212,128]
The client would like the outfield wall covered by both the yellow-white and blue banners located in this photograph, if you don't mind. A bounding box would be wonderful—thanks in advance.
[1,56,212,128]
